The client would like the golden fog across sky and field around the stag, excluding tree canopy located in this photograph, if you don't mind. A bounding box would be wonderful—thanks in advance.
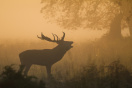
[0,0,132,79]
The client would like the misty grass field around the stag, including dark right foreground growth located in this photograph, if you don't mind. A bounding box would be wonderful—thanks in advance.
[0,37,132,88]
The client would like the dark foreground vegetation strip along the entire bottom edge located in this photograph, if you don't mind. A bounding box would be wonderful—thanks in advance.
[0,61,132,88]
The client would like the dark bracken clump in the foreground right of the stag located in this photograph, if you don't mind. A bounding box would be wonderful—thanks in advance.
[66,61,132,88]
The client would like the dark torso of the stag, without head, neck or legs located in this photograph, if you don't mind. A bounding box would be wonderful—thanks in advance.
[19,45,69,66]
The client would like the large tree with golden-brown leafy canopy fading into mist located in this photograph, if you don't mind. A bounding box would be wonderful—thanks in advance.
[41,0,132,37]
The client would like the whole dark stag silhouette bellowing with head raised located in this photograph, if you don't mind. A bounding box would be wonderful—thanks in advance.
[19,32,73,77]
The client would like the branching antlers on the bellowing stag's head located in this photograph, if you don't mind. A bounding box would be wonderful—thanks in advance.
[37,32,65,43]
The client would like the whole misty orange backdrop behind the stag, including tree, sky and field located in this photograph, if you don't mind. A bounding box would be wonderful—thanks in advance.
[0,0,132,79]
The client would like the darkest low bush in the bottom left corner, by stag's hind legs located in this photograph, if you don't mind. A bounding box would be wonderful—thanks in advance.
[0,65,45,88]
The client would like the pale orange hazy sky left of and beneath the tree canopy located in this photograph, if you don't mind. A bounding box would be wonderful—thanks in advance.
[0,0,107,40]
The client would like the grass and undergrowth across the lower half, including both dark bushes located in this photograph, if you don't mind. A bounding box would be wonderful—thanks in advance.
[0,40,132,88]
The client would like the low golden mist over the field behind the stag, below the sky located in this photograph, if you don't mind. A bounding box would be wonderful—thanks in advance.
[0,31,132,79]
